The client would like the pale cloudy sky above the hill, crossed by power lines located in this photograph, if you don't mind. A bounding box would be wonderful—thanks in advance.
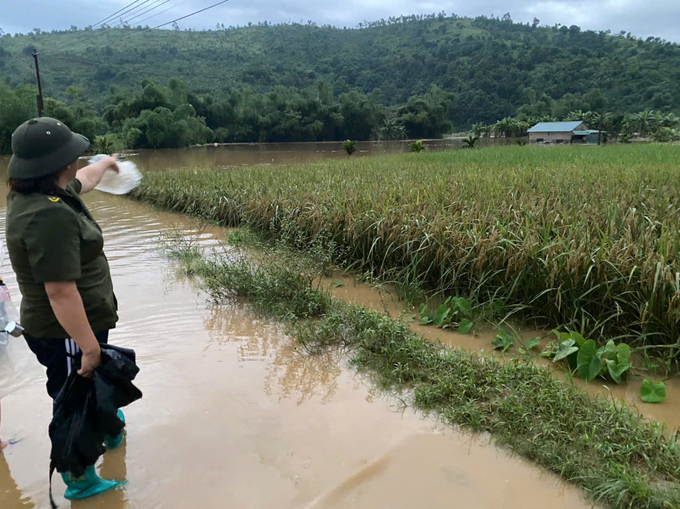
[0,0,680,42]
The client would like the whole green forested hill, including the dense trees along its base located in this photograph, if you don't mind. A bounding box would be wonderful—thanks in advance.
[0,13,680,153]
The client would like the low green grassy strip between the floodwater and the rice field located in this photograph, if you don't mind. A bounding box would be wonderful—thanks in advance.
[169,239,680,509]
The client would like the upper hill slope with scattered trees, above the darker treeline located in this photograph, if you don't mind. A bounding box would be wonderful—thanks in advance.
[0,13,680,128]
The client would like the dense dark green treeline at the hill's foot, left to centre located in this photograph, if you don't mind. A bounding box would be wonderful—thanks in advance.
[0,79,452,153]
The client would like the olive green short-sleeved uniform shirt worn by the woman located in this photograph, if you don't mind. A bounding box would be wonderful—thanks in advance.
[5,180,118,339]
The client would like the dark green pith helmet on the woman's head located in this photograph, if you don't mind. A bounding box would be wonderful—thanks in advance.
[8,117,90,179]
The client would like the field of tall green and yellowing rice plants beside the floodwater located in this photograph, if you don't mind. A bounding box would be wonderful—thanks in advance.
[135,145,680,360]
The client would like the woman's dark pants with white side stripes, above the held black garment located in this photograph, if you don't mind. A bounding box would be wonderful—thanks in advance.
[24,330,109,399]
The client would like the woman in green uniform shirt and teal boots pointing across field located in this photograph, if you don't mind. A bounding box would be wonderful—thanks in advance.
[6,117,123,500]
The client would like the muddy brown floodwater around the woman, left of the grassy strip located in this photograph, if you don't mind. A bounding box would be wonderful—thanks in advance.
[0,152,591,509]
